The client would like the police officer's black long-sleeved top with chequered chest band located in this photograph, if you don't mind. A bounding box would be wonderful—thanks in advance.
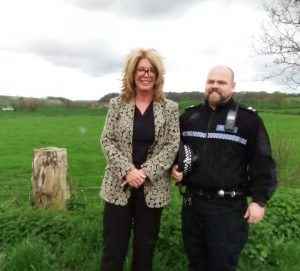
[180,99,277,205]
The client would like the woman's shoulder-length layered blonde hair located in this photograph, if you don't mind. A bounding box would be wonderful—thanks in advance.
[122,49,165,101]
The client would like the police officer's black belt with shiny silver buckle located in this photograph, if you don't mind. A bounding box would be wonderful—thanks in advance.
[186,189,246,199]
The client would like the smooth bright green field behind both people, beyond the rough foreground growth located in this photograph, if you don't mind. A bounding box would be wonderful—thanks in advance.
[0,109,300,206]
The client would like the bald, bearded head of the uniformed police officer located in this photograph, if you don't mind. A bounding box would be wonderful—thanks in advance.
[205,66,235,109]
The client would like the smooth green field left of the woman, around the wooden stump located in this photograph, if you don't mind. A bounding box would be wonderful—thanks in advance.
[0,110,105,206]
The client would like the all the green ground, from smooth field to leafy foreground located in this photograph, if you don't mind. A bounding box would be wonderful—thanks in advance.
[0,109,300,271]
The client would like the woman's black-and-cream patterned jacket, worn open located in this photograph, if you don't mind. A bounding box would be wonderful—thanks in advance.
[100,96,180,208]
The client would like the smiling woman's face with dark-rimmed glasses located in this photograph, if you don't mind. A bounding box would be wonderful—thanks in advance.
[134,58,157,93]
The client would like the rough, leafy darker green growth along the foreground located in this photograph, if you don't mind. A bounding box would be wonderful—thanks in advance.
[0,185,300,271]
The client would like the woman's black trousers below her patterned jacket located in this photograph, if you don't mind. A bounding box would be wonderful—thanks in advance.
[100,187,163,271]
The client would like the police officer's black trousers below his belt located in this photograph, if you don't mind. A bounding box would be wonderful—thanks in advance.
[182,195,249,271]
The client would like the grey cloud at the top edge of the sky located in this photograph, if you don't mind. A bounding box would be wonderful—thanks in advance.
[65,0,202,18]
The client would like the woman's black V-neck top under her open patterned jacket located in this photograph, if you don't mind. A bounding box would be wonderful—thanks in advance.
[132,103,155,168]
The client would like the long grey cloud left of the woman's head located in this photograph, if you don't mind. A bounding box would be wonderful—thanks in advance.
[22,40,123,76]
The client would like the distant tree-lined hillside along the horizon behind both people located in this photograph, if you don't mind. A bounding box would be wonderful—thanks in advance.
[0,91,300,114]
